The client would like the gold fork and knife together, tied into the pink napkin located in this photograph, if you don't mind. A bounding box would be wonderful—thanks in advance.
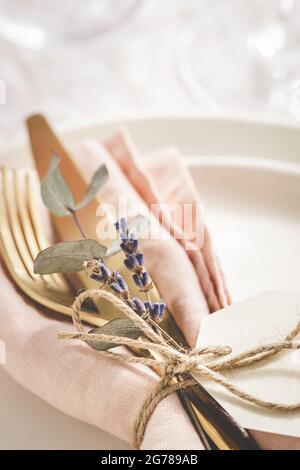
[0,115,258,450]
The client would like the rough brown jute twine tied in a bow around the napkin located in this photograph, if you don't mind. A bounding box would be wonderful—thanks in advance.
[58,289,300,448]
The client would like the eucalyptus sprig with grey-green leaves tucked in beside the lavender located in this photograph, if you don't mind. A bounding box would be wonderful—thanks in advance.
[34,154,154,350]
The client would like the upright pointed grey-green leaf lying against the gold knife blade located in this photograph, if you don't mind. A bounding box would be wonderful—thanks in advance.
[41,153,74,216]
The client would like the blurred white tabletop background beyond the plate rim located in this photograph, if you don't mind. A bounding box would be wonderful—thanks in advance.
[0,0,300,148]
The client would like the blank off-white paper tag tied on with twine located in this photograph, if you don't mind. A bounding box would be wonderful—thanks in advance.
[193,291,300,437]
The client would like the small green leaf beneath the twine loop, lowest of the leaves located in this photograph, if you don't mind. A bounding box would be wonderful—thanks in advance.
[87,318,143,351]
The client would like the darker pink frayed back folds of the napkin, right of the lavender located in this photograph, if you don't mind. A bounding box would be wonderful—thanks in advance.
[105,131,231,312]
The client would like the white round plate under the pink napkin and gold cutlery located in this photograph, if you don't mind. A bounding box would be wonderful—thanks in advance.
[0,116,300,449]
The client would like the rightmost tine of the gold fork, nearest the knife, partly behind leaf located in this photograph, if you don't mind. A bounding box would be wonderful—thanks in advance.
[25,172,70,292]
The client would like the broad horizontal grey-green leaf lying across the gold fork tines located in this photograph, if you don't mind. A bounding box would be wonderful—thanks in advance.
[34,238,106,274]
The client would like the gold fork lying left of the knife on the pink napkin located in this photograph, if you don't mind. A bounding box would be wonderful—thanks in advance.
[0,167,106,326]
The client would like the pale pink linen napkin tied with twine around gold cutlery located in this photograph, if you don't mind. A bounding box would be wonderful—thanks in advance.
[0,133,299,449]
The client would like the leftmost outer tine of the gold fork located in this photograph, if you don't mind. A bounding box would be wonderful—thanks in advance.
[0,168,32,279]
